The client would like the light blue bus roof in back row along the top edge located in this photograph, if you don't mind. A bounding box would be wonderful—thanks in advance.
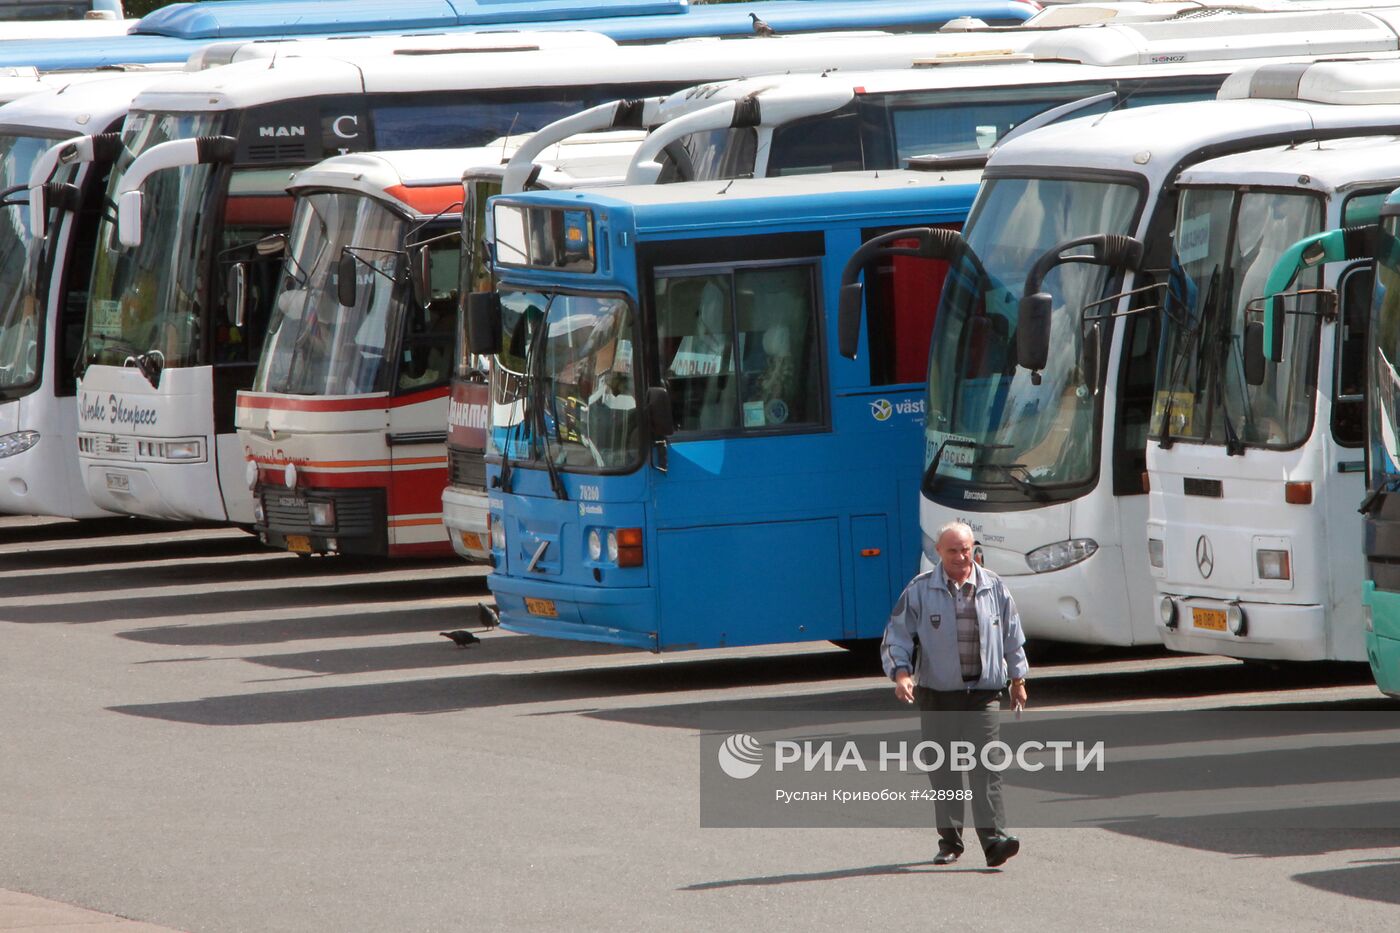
[0,0,1037,71]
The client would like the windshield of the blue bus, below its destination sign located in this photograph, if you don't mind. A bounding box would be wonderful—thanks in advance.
[487,291,641,472]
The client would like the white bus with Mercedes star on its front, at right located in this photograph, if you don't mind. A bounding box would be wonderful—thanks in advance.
[1147,136,1400,661]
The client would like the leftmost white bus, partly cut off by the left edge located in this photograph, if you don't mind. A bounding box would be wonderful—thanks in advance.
[0,73,170,518]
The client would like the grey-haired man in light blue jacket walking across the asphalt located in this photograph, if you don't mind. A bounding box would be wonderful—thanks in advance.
[881,521,1028,867]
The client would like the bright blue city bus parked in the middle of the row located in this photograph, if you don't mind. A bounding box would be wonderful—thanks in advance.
[463,171,979,651]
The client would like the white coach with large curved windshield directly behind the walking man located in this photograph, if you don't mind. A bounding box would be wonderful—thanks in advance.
[851,64,1400,644]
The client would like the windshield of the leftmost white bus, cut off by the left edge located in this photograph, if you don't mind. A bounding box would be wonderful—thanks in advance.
[0,136,56,392]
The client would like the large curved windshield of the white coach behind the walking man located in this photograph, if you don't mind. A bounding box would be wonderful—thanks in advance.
[924,178,1141,495]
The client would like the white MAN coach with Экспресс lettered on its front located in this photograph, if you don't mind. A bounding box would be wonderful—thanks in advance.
[65,25,1103,524]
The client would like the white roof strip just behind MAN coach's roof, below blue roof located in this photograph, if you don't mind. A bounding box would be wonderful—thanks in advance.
[185,29,617,71]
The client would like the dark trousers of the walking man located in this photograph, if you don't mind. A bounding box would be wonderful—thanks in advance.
[914,686,1007,853]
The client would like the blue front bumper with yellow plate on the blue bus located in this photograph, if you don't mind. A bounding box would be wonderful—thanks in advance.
[486,573,659,651]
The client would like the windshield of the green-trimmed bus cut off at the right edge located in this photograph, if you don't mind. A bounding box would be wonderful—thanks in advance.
[1368,216,1400,490]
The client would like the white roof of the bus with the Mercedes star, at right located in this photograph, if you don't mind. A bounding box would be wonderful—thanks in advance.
[1177,136,1400,193]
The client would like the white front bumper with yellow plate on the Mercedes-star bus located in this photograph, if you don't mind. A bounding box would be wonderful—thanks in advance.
[1158,594,1327,661]
